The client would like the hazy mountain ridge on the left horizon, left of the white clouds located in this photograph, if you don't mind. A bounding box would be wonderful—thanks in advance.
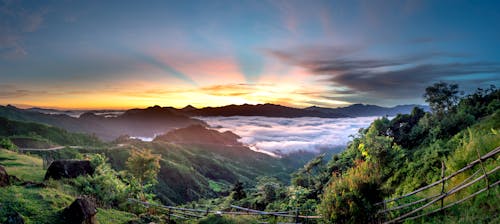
[0,105,205,141]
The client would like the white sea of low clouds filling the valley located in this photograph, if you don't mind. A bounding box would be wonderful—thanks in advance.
[199,116,377,156]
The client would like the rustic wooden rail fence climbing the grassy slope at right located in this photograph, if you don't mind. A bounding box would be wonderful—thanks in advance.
[375,147,500,224]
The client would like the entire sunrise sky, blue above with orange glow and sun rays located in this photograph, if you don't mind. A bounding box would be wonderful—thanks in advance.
[0,0,500,109]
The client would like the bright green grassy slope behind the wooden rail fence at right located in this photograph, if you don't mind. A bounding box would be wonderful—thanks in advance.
[399,111,500,223]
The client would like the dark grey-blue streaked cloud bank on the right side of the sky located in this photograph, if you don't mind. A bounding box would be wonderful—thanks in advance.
[268,46,500,100]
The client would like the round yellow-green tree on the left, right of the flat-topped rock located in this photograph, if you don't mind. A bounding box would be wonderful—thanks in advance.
[126,149,160,185]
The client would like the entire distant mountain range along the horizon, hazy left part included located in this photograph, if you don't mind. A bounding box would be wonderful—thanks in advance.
[0,104,428,141]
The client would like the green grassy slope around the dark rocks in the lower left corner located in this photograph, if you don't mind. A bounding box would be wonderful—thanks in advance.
[0,149,135,224]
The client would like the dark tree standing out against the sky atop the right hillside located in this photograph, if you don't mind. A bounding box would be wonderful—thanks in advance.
[424,82,459,116]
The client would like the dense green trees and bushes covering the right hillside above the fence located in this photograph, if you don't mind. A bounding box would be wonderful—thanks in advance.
[316,83,500,223]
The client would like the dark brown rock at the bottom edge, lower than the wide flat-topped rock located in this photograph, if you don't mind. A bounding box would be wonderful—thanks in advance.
[62,197,97,224]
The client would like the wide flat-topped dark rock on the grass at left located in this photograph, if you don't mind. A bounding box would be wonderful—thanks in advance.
[45,160,94,180]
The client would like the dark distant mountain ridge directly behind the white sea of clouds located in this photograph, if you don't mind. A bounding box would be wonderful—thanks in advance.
[176,103,428,118]
